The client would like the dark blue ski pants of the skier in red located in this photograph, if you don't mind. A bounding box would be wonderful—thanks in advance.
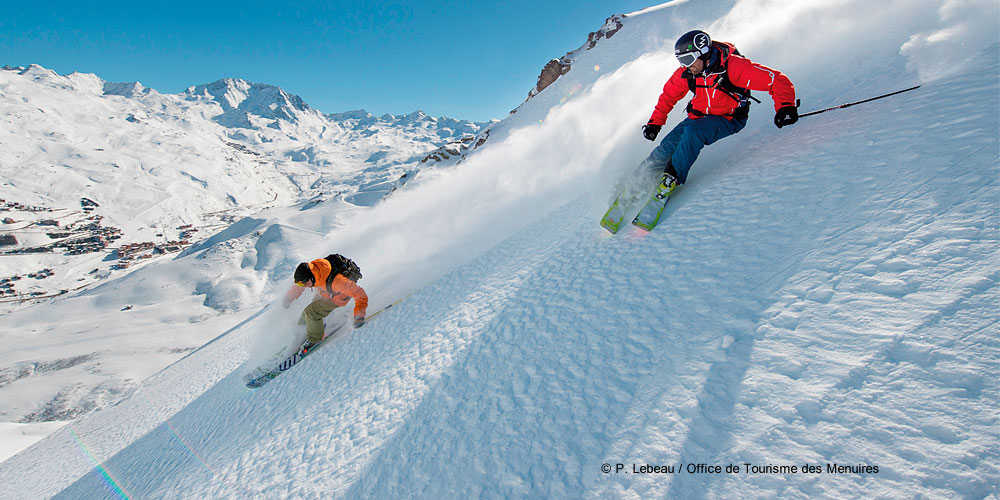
[644,115,747,184]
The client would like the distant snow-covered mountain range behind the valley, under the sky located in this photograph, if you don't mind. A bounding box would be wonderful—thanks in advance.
[0,65,489,311]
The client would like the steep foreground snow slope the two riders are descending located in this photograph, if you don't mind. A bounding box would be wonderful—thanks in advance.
[0,2,1000,498]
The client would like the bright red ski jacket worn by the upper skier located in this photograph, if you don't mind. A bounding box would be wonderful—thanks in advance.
[649,42,795,125]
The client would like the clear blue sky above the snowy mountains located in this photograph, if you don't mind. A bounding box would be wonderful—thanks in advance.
[0,0,666,120]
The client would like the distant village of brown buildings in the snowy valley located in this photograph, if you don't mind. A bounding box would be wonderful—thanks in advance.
[0,198,198,298]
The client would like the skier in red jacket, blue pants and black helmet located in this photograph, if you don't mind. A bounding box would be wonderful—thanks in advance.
[642,30,799,196]
